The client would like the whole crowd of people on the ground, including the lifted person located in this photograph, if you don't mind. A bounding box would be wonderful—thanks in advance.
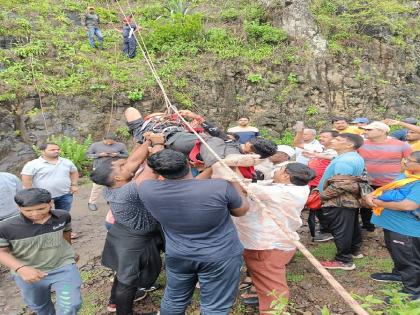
[0,107,420,315]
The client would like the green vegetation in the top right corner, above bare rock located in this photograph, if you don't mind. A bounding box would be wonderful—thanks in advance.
[311,0,420,53]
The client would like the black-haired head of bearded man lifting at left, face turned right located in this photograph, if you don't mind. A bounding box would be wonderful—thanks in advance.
[90,158,134,187]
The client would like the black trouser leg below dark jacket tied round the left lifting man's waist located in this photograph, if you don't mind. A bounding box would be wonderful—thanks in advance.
[109,276,137,315]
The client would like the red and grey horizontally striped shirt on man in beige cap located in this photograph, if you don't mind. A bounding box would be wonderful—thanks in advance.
[359,138,412,186]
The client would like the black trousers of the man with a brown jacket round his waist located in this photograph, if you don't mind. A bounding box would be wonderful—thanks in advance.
[320,207,362,263]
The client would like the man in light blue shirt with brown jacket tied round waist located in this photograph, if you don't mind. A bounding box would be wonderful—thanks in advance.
[318,133,365,270]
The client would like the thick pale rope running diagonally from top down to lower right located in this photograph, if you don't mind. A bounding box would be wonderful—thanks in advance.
[110,0,368,315]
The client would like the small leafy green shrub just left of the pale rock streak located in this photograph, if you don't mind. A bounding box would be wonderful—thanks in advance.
[245,22,287,44]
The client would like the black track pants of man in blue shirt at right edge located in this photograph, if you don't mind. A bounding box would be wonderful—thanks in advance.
[384,229,420,295]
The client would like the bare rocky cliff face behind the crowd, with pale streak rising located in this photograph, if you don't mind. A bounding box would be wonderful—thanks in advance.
[0,0,420,172]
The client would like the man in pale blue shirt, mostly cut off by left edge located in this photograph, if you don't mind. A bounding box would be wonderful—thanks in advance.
[0,172,23,221]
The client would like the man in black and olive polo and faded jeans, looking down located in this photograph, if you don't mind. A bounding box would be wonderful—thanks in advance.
[0,188,82,315]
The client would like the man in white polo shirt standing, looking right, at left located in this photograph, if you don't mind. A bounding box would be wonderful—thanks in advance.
[21,143,79,212]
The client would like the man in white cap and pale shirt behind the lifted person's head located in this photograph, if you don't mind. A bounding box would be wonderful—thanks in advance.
[255,145,295,179]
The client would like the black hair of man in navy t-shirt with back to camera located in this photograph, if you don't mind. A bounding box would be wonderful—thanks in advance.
[147,149,190,179]
